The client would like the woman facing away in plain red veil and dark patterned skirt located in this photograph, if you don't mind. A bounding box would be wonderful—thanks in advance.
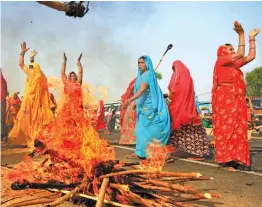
[168,60,208,159]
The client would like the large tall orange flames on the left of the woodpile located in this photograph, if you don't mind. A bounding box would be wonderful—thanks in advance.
[2,78,115,184]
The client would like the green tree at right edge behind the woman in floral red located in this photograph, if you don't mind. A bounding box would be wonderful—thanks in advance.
[246,66,262,96]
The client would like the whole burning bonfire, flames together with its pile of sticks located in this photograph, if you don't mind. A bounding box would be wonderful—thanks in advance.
[1,85,219,207]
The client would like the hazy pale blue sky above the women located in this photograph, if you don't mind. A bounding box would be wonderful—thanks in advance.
[1,1,262,102]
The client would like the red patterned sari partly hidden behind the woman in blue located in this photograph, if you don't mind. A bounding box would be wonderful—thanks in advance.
[119,78,136,145]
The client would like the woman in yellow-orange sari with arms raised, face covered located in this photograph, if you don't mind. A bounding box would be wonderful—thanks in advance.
[9,42,53,147]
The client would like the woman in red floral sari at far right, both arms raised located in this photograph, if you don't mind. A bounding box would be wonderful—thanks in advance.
[212,22,259,171]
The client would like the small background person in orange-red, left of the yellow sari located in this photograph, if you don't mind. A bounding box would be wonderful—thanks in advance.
[6,93,21,130]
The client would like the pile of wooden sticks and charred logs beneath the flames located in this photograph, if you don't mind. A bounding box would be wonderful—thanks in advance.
[1,161,220,207]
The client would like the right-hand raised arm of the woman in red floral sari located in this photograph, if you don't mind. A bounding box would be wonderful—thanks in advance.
[237,29,260,67]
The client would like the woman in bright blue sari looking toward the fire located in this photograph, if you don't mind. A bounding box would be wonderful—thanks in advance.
[123,56,170,159]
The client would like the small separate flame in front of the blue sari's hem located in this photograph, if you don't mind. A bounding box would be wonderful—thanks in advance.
[140,139,175,171]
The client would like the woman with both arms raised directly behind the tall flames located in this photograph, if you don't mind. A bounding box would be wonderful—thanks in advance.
[61,53,83,111]
